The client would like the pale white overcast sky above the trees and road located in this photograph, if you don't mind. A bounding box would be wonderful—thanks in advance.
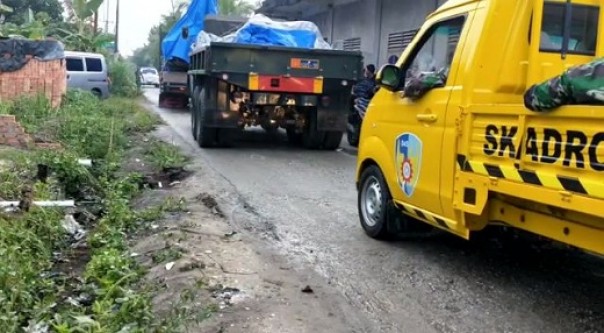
[99,0,253,56]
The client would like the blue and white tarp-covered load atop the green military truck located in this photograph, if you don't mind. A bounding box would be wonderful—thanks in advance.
[192,14,331,51]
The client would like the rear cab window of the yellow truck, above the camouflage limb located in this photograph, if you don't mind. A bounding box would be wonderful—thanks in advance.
[540,2,600,55]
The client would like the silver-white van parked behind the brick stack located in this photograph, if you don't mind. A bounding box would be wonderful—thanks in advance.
[65,51,109,98]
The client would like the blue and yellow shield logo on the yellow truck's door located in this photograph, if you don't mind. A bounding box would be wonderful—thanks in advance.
[395,133,423,197]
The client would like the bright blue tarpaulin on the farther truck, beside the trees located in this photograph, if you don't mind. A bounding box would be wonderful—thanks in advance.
[162,0,218,64]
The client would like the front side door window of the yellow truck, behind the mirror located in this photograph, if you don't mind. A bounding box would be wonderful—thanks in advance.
[406,17,465,84]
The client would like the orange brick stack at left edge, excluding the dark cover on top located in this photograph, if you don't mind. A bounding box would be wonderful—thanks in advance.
[0,56,67,108]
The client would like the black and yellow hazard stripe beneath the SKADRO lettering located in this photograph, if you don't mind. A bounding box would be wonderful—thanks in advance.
[457,155,604,198]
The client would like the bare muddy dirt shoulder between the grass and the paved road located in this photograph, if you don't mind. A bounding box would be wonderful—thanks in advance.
[137,113,369,333]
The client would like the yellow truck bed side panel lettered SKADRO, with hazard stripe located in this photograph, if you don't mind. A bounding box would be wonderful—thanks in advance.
[458,106,604,203]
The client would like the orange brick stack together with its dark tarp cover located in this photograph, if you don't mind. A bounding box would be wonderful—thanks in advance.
[0,38,67,107]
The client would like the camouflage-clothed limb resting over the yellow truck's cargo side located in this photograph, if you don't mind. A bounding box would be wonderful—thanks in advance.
[524,58,604,112]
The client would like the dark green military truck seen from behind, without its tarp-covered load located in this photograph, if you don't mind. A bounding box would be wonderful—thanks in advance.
[188,42,363,150]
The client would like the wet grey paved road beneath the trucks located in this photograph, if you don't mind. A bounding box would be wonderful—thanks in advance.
[146,90,604,333]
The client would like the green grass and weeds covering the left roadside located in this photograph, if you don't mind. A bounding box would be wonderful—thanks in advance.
[0,92,198,333]
